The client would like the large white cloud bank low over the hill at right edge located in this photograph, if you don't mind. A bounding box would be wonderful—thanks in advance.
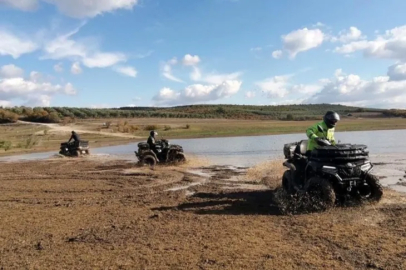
[304,68,406,108]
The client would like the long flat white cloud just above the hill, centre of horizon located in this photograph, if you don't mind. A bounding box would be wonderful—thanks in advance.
[153,81,242,105]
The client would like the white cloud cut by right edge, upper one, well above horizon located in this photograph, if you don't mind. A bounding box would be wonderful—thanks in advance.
[334,25,406,61]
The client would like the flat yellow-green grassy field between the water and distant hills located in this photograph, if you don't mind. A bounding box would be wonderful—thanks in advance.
[0,118,406,155]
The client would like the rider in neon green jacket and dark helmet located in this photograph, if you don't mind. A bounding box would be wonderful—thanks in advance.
[306,111,340,151]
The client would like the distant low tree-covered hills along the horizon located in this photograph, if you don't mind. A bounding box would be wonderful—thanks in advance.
[0,104,400,123]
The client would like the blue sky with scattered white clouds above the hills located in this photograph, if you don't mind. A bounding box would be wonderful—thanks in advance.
[0,0,406,108]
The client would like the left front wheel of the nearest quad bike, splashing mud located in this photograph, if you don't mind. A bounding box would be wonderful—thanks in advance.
[306,177,336,209]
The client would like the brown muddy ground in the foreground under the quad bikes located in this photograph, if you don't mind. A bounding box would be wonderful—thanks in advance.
[0,159,406,269]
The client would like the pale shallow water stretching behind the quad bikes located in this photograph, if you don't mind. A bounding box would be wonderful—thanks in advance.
[0,130,406,191]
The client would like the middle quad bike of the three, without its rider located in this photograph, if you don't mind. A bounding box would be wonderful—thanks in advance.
[135,139,186,166]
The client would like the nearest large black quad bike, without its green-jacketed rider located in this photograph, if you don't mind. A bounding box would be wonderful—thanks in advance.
[282,127,383,208]
